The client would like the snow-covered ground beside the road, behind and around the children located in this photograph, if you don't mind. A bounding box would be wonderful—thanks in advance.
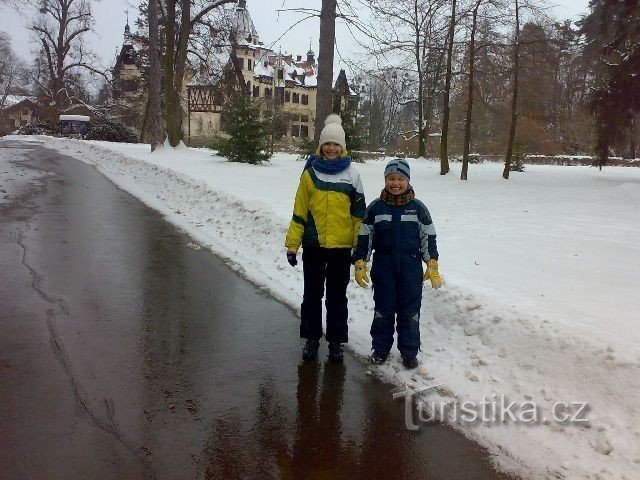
[5,137,640,480]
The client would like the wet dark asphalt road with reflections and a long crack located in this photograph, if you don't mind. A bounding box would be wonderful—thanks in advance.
[0,139,506,480]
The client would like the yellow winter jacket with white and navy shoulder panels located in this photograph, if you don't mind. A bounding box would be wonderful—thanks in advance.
[285,165,366,251]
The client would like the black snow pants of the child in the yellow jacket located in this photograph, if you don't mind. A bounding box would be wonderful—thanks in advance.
[300,247,351,343]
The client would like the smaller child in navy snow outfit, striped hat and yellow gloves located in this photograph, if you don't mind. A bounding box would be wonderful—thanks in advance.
[354,159,442,368]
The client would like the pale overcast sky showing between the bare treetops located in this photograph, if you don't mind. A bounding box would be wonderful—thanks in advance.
[0,0,589,72]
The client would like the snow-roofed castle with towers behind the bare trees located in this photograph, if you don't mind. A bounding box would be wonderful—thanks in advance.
[113,0,358,145]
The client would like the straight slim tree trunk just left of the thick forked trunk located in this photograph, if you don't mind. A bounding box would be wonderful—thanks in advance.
[146,0,163,152]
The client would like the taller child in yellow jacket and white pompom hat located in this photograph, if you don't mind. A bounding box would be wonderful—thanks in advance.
[285,114,366,361]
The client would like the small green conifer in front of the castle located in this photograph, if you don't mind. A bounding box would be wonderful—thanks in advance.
[218,92,271,164]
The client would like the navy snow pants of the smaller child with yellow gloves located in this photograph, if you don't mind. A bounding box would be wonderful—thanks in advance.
[371,252,423,357]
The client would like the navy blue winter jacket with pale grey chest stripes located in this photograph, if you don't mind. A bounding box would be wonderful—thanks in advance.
[354,198,438,262]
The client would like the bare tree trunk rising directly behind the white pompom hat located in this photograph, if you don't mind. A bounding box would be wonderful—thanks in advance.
[314,0,337,142]
